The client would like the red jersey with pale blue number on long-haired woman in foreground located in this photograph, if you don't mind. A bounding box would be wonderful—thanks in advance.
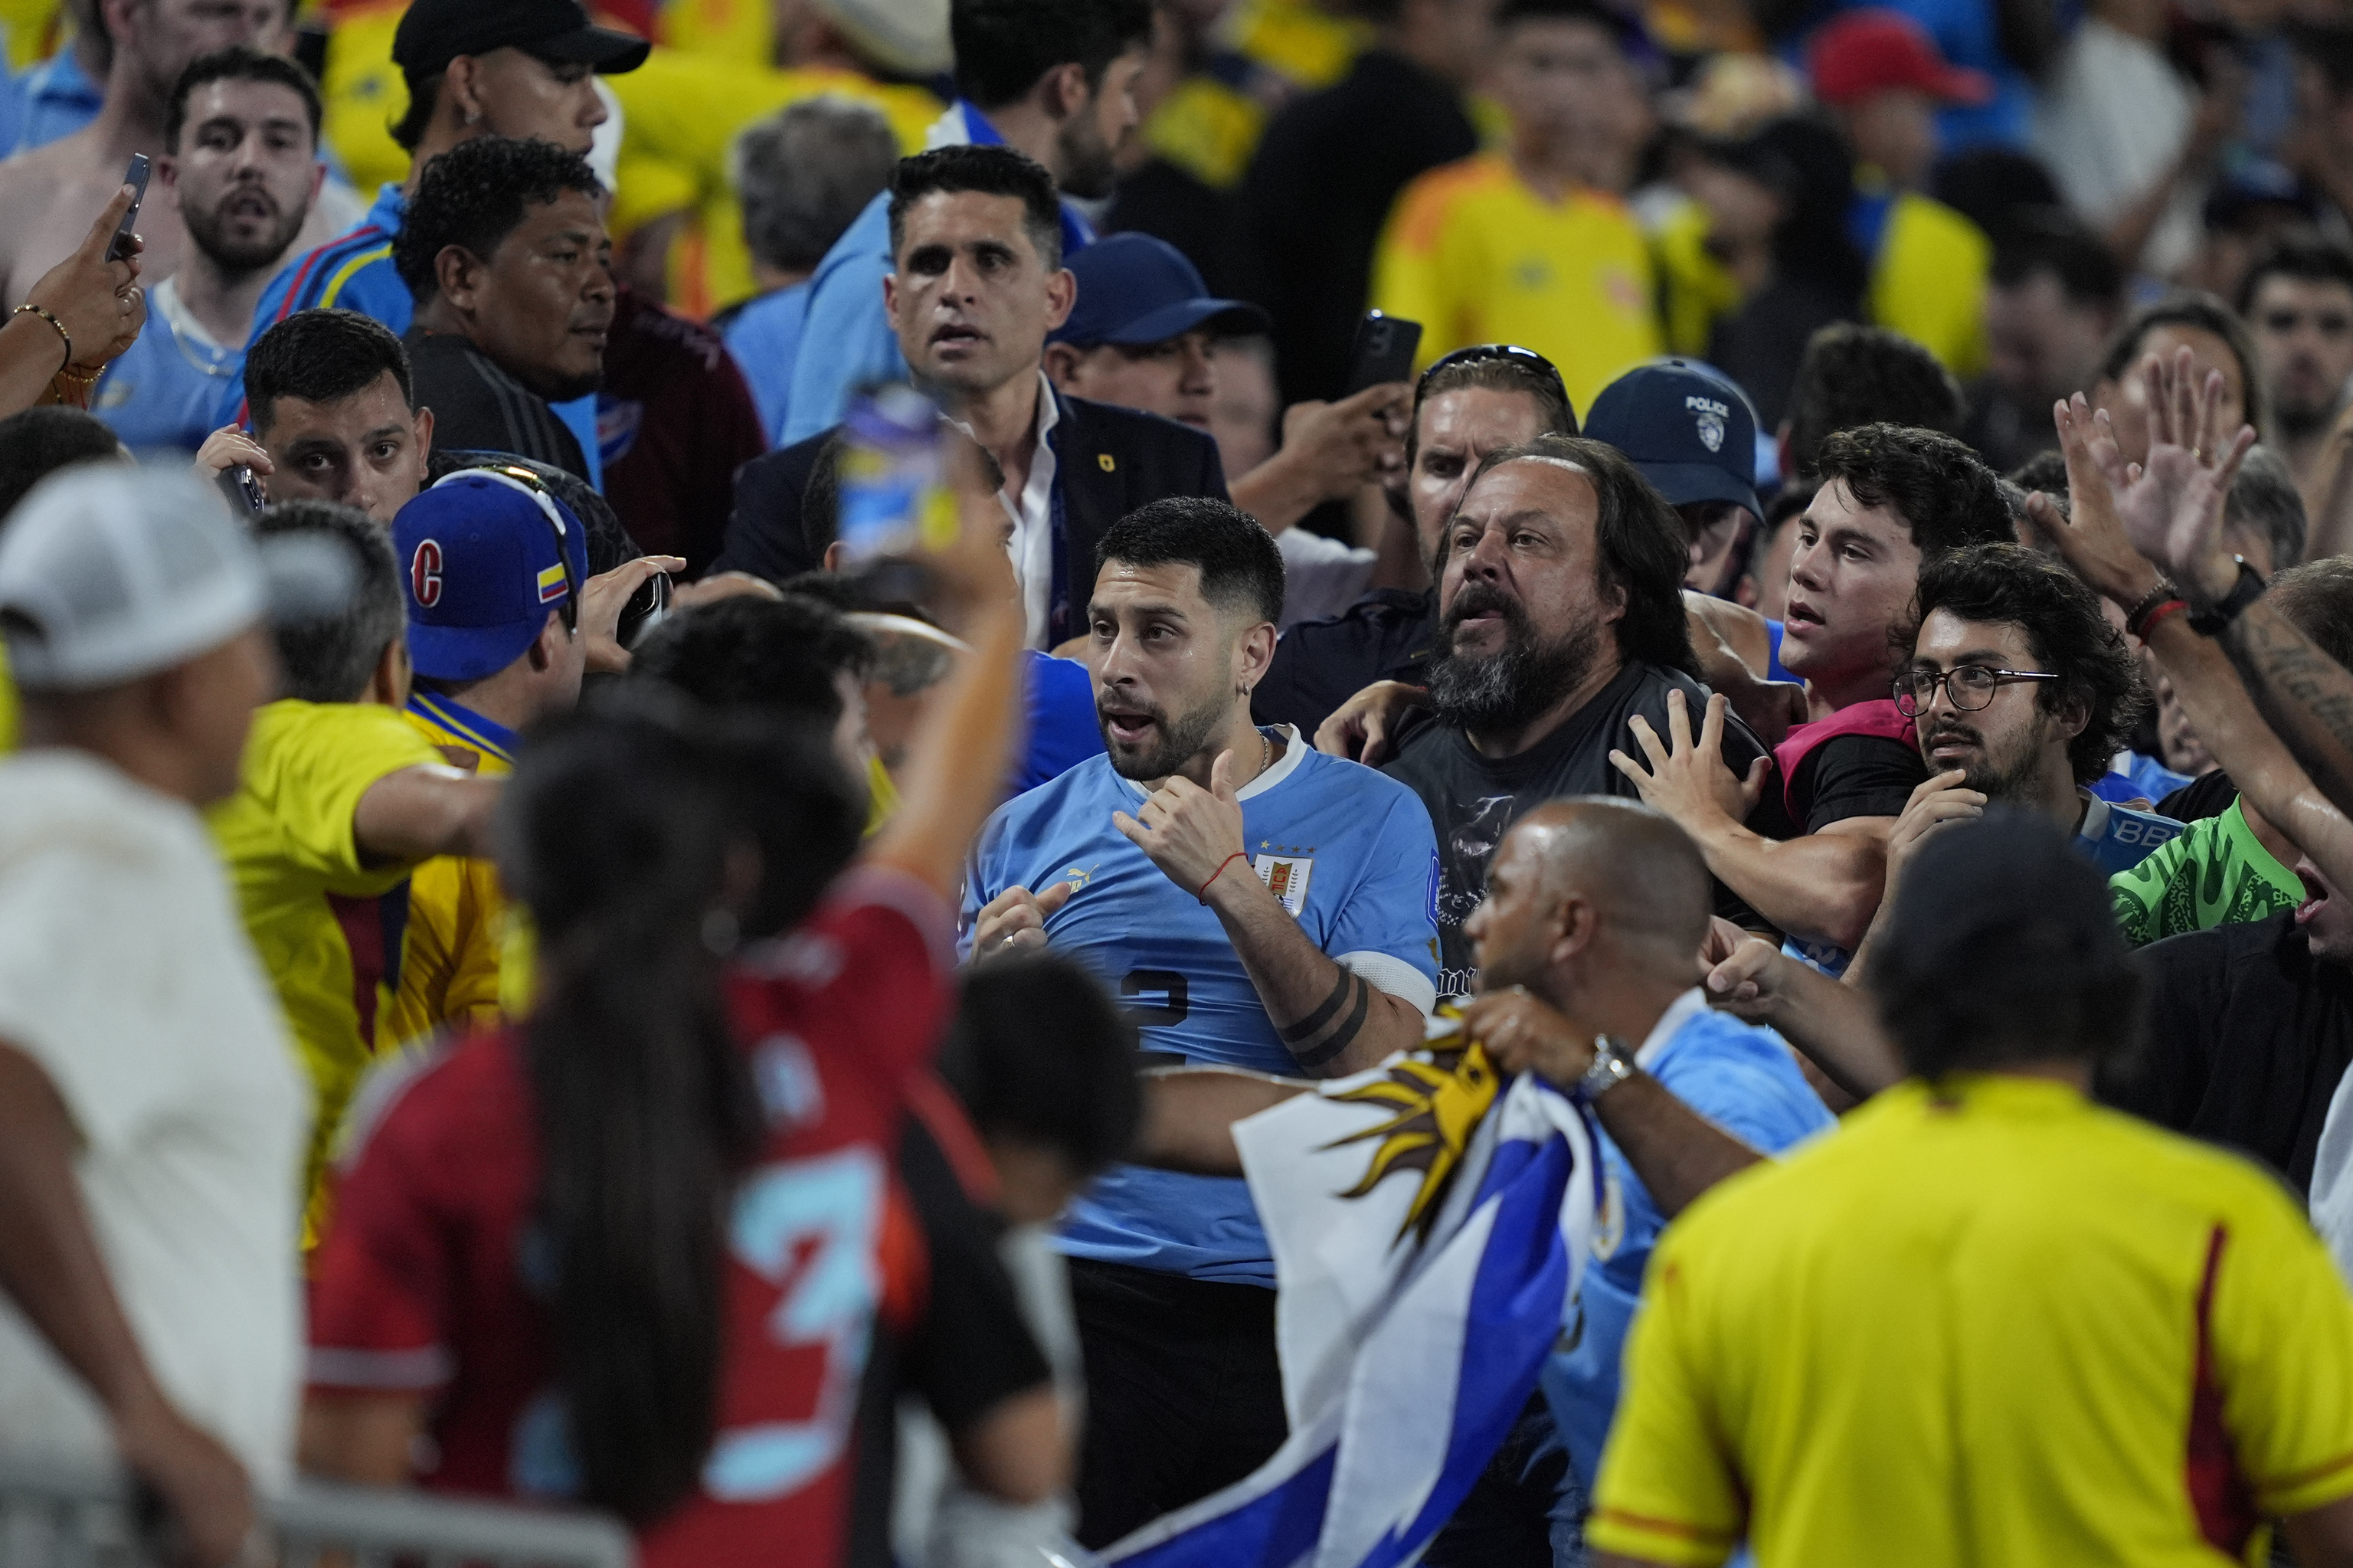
[308,869,955,1568]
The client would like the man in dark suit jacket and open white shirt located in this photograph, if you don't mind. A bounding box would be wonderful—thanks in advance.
[715,146,1226,647]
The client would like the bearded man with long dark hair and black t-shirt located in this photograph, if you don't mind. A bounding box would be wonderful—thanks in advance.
[1383,436,1786,996]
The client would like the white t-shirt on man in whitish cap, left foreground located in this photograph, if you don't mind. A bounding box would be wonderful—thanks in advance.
[0,751,308,1488]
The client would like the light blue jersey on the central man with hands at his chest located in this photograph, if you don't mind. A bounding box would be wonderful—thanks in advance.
[962,730,1438,1285]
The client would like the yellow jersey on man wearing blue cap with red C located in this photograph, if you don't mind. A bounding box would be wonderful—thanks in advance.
[377,692,515,1050]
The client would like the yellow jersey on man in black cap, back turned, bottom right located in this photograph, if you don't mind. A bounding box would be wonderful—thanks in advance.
[1586,1076,2353,1568]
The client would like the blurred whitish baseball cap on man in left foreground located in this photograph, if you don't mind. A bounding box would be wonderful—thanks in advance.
[0,463,355,692]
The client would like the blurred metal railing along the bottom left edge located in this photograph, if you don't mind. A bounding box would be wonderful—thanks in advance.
[0,1455,635,1568]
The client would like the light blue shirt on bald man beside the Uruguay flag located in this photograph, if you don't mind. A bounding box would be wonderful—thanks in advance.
[1541,987,1838,1491]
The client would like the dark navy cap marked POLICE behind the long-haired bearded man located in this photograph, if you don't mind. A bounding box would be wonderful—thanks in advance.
[1586,360,1765,518]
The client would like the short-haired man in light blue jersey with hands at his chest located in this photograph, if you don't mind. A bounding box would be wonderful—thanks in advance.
[962,497,1440,1547]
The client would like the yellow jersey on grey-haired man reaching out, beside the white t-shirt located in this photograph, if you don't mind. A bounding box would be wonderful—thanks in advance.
[207,699,443,1193]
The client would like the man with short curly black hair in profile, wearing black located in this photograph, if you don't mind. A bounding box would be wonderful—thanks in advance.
[393,136,614,478]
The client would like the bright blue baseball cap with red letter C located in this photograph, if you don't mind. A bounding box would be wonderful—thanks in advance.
[393,469,588,680]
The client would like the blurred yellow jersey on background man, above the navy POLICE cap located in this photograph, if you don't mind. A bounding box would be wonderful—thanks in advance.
[1372,153,1664,417]
